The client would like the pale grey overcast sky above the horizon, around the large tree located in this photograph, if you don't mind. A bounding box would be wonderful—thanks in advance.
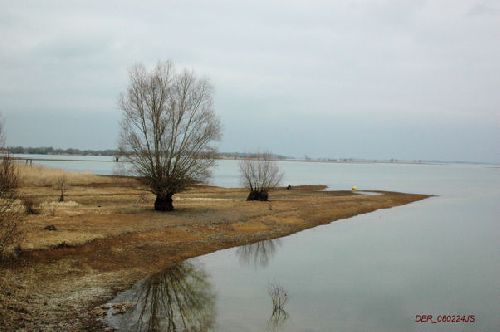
[0,0,500,162]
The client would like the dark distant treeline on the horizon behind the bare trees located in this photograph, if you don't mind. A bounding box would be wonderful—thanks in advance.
[7,146,293,160]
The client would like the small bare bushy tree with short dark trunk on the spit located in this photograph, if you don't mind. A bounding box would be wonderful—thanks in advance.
[240,152,283,201]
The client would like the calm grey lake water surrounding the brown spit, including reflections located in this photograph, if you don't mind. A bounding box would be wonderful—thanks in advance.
[15,158,500,331]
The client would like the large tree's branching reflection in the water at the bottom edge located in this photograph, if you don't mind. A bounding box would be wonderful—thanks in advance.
[109,262,215,332]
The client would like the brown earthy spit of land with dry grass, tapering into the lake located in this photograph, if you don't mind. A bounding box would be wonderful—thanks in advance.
[0,169,429,331]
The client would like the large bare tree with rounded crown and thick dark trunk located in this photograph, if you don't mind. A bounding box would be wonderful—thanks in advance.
[119,61,221,211]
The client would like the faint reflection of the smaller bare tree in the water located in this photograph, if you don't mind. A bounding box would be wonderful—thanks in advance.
[236,239,281,267]
